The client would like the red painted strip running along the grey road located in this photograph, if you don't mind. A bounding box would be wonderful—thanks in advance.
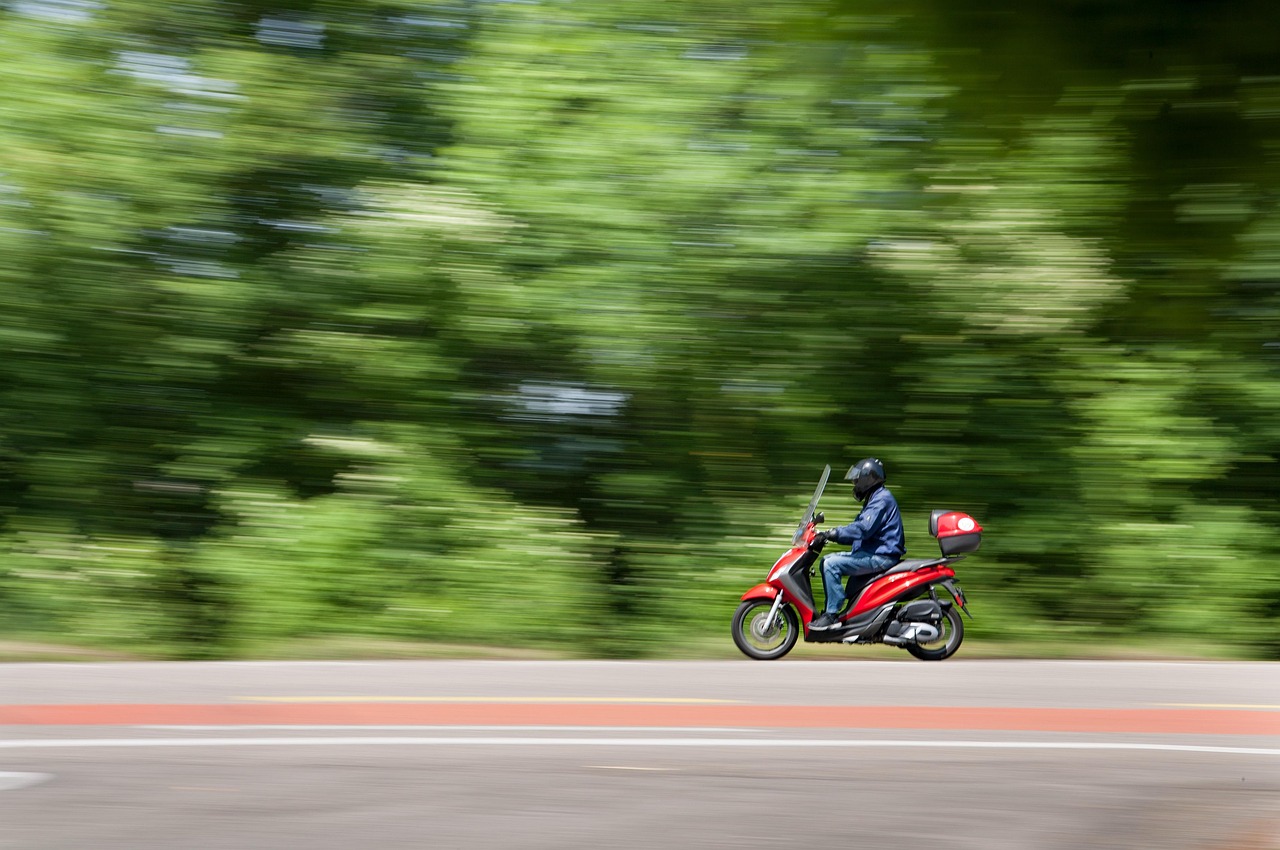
[0,703,1280,735]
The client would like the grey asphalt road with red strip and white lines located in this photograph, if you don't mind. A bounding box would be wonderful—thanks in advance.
[0,659,1280,850]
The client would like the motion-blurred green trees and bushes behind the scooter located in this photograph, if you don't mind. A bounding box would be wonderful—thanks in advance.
[0,0,1280,658]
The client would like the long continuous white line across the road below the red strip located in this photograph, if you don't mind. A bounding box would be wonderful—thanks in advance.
[0,736,1280,755]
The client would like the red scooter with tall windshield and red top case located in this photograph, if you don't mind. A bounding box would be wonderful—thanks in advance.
[733,466,982,661]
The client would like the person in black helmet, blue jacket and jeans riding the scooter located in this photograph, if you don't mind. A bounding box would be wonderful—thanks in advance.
[809,457,906,631]
